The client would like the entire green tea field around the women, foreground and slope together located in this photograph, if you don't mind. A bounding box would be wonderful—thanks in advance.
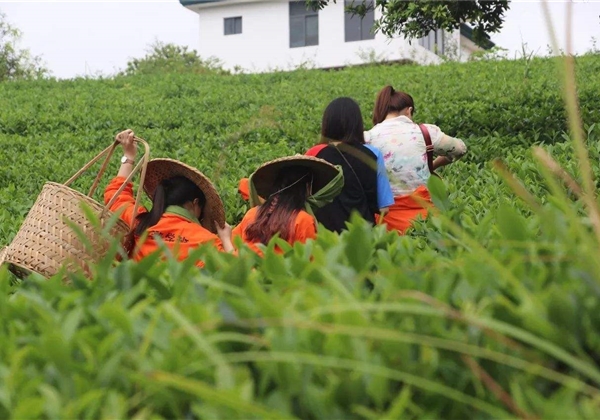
[0,56,600,419]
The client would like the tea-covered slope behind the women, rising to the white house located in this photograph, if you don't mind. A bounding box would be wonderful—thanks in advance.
[0,56,600,244]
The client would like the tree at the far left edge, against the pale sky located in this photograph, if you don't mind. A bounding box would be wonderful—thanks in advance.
[0,12,49,82]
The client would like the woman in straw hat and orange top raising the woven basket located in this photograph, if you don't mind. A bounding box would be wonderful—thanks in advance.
[104,130,234,267]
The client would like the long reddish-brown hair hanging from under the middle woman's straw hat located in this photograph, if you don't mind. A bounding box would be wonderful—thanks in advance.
[245,166,312,245]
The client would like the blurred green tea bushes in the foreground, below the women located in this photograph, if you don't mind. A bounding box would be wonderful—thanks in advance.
[0,195,600,419]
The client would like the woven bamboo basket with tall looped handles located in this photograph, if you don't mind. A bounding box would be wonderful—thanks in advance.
[0,138,150,278]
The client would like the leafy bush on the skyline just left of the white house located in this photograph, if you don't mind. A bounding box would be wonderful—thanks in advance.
[124,41,226,75]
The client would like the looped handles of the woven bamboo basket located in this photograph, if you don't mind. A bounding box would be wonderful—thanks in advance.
[64,137,150,227]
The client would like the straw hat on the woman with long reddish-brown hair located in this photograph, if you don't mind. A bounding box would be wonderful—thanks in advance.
[252,155,339,199]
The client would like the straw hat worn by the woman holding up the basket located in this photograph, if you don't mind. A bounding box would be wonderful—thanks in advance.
[144,159,225,233]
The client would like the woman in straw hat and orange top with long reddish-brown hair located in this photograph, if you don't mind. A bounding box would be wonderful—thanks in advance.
[233,155,343,255]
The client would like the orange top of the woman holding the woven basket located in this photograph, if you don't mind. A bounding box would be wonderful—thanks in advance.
[104,177,223,267]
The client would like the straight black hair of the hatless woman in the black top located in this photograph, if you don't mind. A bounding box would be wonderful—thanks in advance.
[321,97,365,144]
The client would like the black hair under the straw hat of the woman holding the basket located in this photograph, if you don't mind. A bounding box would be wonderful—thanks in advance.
[134,176,206,236]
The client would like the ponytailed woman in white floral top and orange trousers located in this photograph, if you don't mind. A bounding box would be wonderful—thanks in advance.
[365,86,467,234]
